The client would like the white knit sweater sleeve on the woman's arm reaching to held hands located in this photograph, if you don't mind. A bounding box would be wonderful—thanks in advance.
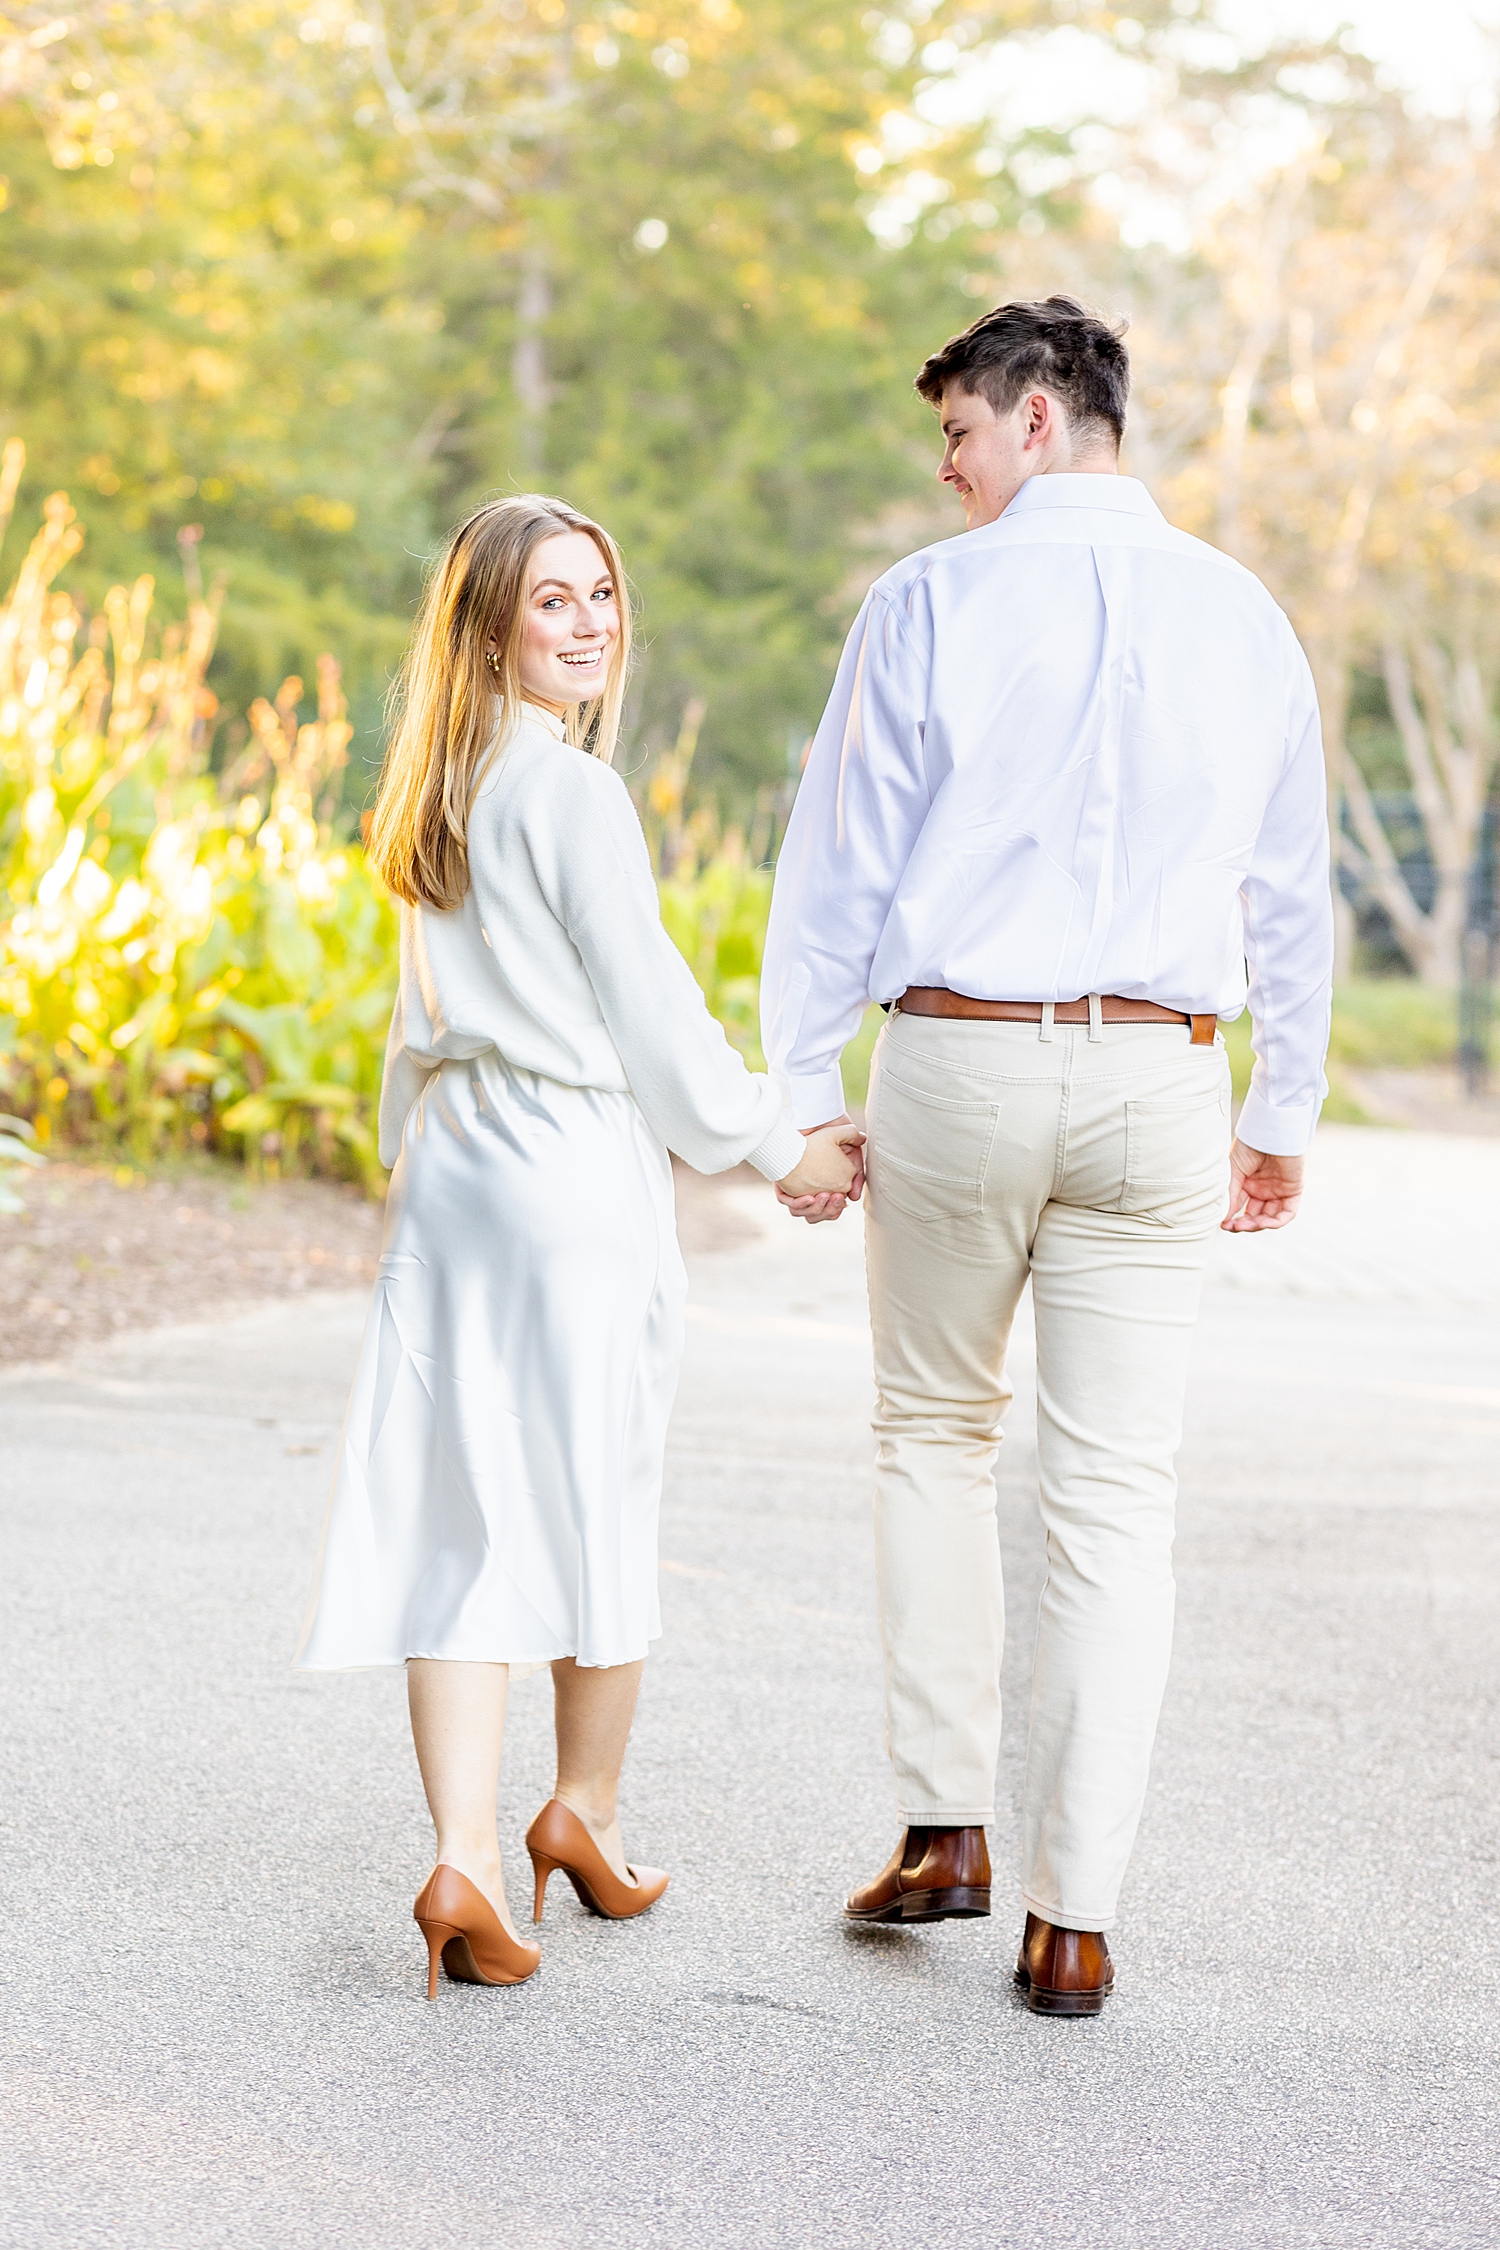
[528,756,803,1179]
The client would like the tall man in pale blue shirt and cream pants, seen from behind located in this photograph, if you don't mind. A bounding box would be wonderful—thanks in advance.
[762,297,1331,2016]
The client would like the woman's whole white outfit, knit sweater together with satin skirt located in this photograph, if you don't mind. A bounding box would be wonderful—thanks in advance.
[297,713,803,1670]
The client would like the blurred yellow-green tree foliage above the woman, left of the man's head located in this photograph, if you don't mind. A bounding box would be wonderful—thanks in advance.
[0,0,1111,801]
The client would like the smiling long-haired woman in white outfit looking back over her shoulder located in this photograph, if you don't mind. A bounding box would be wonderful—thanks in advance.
[297,495,857,1998]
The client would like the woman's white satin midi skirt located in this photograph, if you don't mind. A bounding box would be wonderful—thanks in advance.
[297,1051,686,1672]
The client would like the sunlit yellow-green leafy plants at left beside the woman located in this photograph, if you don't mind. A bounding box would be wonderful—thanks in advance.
[0,474,396,1190]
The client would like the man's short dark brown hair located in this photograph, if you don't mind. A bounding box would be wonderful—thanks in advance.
[918,297,1131,446]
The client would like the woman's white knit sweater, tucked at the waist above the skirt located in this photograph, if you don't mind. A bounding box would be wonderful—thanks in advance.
[380,704,805,1179]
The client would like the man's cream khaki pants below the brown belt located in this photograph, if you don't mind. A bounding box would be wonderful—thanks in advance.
[866,1013,1230,1931]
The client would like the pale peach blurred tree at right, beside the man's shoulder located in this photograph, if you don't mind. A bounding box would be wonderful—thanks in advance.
[1110,54,1500,986]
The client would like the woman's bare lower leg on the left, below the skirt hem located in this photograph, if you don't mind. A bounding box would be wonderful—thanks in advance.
[407,1656,517,1937]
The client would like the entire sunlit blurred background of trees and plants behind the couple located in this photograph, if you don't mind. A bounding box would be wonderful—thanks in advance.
[0,0,1500,1202]
